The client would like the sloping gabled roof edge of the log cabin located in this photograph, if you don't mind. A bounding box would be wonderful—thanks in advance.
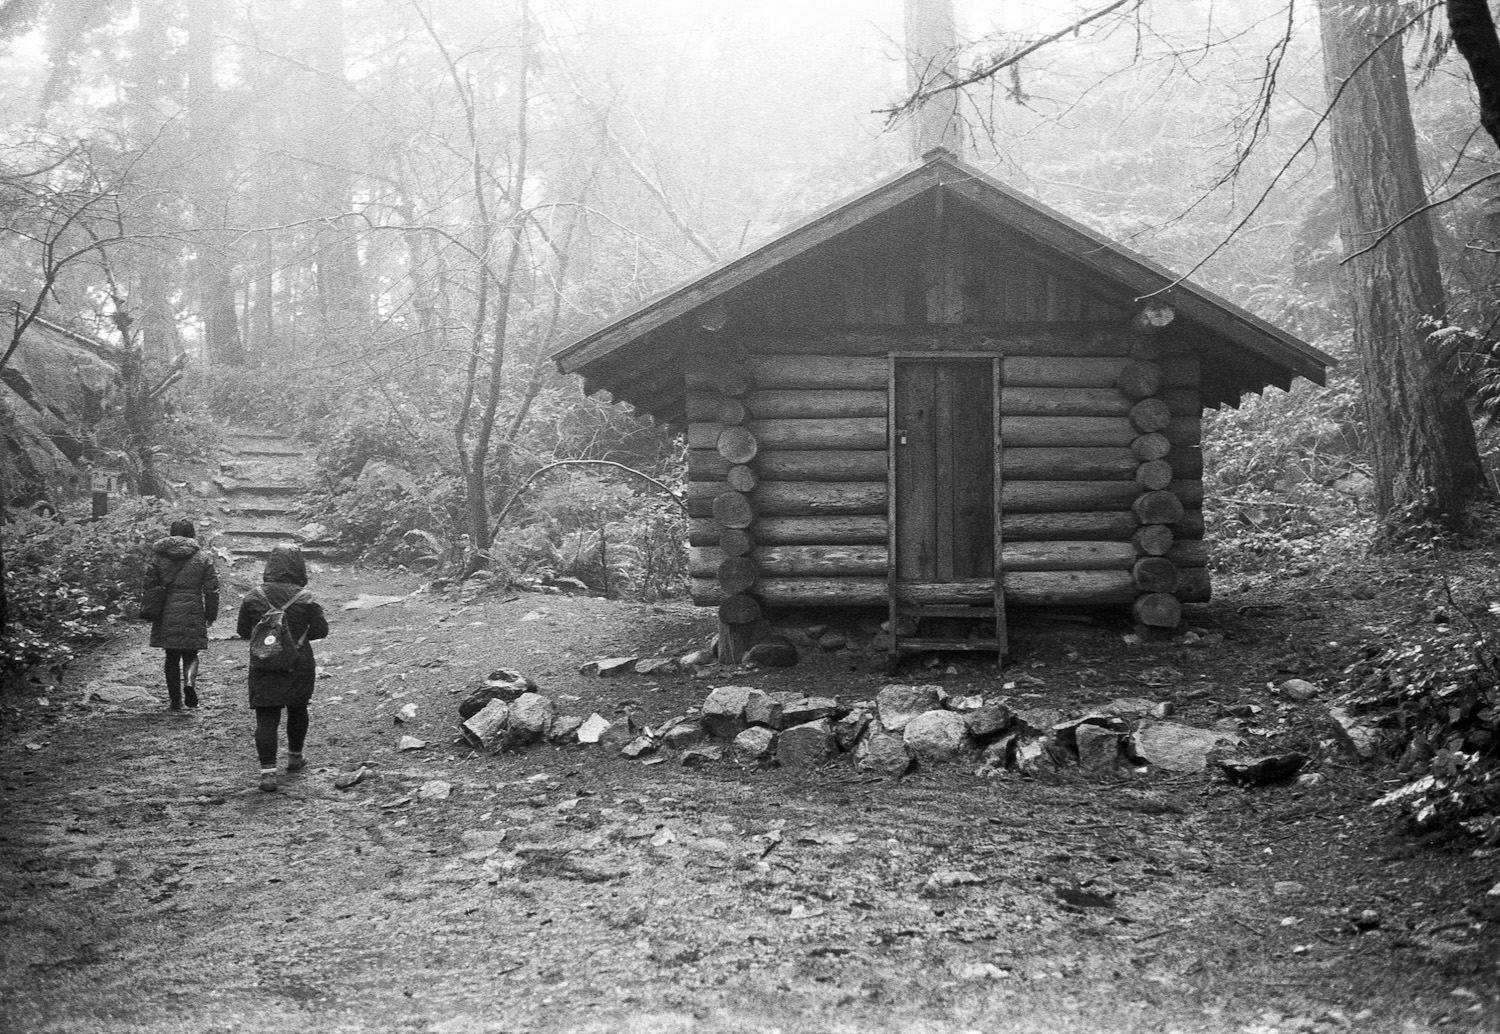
[552,149,1335,420]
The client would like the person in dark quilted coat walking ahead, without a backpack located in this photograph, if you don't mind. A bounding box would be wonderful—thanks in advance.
[141,521,219,711]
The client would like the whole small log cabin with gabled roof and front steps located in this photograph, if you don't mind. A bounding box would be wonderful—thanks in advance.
[554,149,1334,666]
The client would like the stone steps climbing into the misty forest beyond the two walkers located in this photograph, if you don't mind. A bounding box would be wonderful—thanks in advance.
[213,428,332,558]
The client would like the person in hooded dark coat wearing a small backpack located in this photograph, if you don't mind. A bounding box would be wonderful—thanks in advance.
[236,546,329,791]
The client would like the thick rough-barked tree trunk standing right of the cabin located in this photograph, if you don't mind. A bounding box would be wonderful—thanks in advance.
[1319,0,1488,530]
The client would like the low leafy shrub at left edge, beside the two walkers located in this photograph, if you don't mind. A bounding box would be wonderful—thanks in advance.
[0,500,173,671]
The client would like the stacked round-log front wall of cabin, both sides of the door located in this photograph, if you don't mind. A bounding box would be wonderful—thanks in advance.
[687,327,1209,635]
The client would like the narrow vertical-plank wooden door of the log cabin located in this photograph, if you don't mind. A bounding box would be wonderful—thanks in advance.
[891,359,996,582]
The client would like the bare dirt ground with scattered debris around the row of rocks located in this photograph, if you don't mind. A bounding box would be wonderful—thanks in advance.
[0,564,1500,1034]
